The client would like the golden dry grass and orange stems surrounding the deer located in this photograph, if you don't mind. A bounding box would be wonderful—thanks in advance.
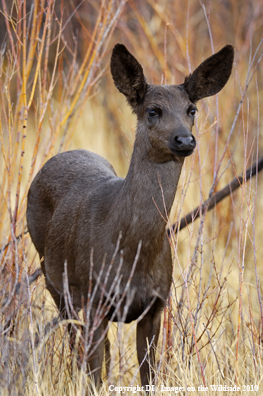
[0,0,263,395]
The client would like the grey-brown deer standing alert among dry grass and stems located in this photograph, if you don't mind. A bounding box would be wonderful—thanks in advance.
[27,44,234,385]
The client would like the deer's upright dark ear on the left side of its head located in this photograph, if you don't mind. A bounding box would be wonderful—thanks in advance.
[111,44,147,109]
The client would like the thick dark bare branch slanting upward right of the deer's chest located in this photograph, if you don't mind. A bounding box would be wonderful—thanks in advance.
[168,157,263,236]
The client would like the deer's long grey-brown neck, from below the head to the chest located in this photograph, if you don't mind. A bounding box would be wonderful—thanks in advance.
[122,125,184,239]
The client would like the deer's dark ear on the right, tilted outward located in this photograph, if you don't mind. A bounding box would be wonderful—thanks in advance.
[182,45,234,103]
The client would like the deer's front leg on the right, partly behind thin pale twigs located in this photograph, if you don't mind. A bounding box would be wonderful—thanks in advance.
[137,310,161,386]
